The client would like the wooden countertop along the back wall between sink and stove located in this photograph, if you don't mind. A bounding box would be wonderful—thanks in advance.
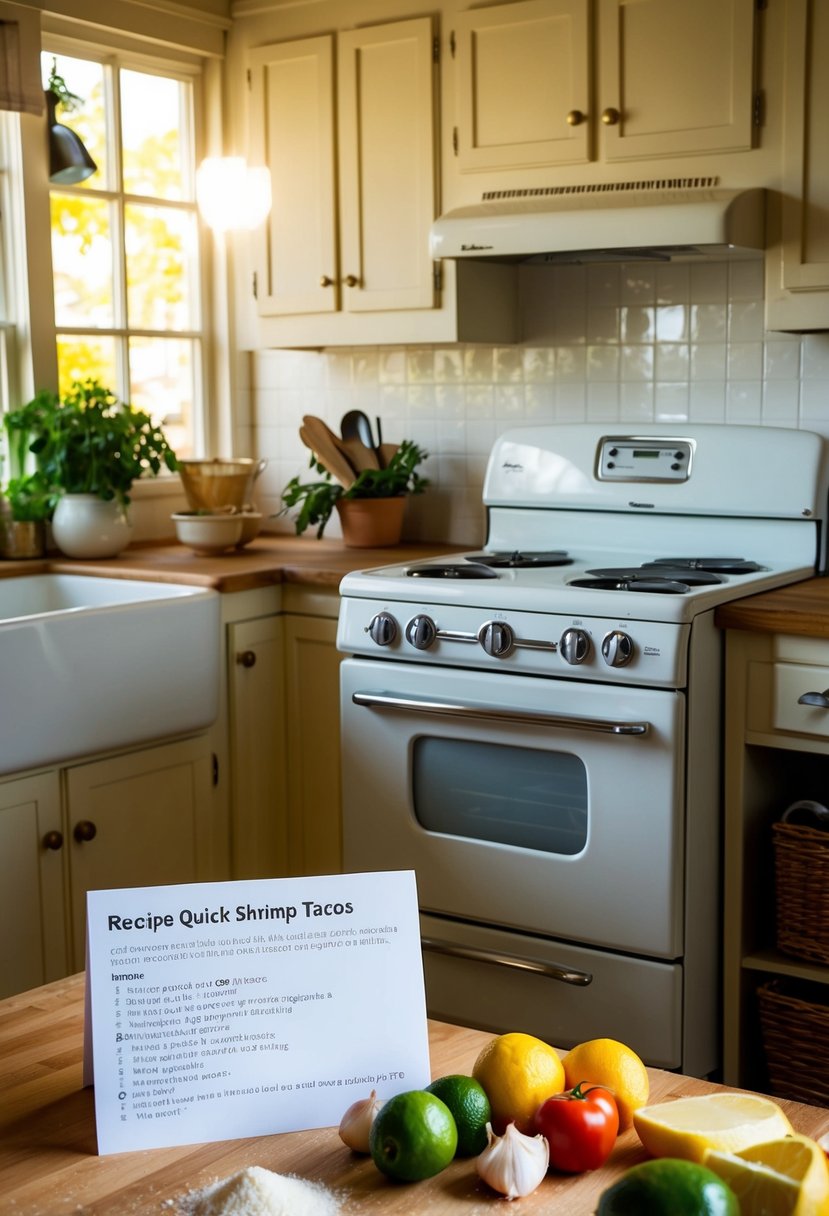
[0,536,468,591]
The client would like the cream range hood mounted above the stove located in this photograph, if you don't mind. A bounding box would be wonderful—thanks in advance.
[429,178,766,264]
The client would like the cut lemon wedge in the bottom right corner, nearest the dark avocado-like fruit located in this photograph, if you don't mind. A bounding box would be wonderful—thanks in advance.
[705,1135,829,1216]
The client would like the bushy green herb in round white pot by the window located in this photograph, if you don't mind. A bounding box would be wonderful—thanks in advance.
[5,378,177,557]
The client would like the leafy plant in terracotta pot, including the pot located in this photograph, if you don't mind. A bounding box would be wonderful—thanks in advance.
[281,439,429,548]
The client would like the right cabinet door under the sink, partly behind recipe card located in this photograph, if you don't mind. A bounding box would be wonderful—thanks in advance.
[64,738,215,968]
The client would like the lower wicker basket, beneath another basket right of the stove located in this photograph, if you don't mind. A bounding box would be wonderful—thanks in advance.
[757,980,829,1107]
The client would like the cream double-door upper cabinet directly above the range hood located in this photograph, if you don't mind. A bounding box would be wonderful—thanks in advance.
[455,0,754,171]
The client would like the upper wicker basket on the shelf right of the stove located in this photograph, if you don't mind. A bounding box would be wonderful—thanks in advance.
[772,823,829,963]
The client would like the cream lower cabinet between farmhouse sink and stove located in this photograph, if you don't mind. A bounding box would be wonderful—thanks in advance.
[224,585,342,878]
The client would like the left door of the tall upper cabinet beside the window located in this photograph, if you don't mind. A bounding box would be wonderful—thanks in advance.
[249,36,339,316]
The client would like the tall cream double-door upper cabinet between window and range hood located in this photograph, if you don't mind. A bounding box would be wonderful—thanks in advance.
[249,17,436,316]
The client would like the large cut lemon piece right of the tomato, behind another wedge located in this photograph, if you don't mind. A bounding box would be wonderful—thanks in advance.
[633,1093,791,1161]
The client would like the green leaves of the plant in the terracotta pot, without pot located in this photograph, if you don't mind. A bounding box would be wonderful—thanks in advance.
[280,439,429,540]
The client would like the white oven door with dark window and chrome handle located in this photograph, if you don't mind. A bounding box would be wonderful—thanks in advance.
[340,659,684,959]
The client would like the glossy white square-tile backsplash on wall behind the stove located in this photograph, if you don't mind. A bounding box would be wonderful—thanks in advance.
[249,260,829,546]
